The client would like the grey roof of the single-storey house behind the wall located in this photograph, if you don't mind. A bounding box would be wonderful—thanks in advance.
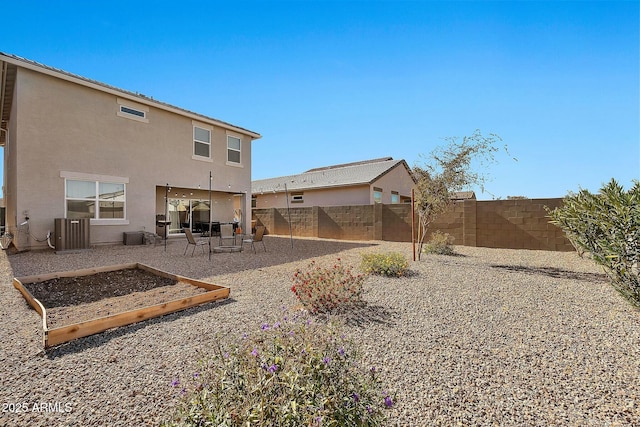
[251,157,413,193]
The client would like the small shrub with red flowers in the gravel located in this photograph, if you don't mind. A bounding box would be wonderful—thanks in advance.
[291,258,364,313]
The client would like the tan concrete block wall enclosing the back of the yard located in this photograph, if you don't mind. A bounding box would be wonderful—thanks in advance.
[252,199,574,251]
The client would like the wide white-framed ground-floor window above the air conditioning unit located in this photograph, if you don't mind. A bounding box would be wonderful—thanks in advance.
[65,179,126,219]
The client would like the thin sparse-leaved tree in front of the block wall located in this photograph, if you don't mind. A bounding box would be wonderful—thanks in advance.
[413,130,515,259]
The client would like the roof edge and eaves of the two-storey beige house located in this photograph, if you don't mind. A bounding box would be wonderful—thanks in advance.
[0,52,261,139]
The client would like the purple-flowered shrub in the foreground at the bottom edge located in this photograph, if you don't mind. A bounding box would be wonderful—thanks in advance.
[163,312,395,427]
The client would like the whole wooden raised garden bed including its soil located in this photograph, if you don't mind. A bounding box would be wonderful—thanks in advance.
[13,263,229,348]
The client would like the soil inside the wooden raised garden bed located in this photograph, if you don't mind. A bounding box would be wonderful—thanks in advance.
[25,269,207,328]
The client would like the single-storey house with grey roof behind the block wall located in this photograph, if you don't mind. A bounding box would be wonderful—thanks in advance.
[251,157,415,209]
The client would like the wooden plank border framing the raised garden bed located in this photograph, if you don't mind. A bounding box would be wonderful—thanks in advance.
[13,263,230,348]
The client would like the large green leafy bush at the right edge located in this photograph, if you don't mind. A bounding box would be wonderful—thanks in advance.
[547,179,640,307]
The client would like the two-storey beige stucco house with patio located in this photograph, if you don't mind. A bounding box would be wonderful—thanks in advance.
[0,53,260,250]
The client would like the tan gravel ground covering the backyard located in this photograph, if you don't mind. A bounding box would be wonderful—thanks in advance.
[0,236,640,426]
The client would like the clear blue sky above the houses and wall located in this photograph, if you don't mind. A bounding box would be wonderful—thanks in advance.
[0,0,640,199]
